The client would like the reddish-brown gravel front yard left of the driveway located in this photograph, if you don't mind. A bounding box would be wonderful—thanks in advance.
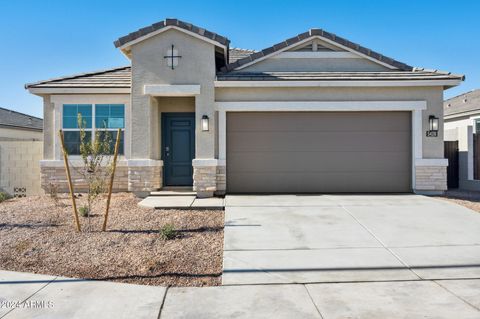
[0,193,224,286]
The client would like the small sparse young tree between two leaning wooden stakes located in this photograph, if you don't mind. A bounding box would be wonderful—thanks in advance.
[75,114,112,230]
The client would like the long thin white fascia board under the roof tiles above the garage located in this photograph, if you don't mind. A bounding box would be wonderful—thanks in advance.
[214,80,462,87]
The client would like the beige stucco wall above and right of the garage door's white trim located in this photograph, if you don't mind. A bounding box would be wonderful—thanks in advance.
[215,87,444,158]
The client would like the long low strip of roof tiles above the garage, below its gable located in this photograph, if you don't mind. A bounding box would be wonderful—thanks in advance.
[217,69,463,81]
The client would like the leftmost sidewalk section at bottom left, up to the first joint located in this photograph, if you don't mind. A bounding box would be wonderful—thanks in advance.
[0,270,167,319]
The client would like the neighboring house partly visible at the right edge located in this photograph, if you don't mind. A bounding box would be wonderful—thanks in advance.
[443,89,480,191]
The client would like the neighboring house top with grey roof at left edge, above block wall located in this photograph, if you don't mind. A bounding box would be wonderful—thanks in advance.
[0,107,43,141]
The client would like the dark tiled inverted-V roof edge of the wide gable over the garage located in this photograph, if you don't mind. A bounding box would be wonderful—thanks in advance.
[222,29,413,72]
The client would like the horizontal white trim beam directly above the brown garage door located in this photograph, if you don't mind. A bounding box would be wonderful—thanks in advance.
[215,101,427,112]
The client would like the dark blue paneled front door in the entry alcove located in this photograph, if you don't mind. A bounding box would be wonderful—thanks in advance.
[162,113,195,186]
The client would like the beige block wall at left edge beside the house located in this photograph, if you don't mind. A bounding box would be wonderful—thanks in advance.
[0,141,43,196]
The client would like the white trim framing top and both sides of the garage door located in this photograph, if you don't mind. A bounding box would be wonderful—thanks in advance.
[215,101,427,189]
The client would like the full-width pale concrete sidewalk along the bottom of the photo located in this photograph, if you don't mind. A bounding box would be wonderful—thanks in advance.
[0,271,480,319]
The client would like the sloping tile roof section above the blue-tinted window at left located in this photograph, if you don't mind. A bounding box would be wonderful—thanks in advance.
[25,66,132,89]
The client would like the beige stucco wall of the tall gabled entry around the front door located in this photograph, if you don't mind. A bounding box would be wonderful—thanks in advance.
[131,29,215,158]
